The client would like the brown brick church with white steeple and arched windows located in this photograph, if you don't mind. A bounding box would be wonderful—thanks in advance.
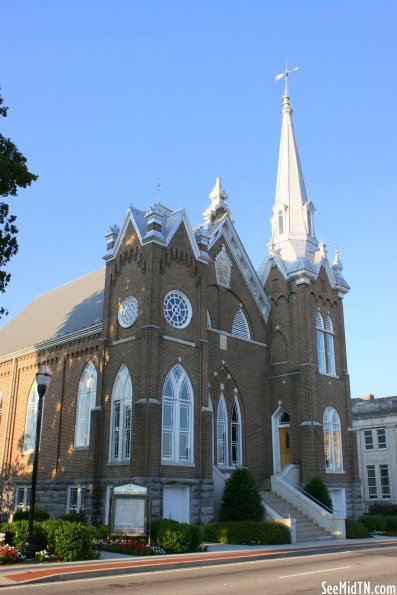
[0,79,360,523]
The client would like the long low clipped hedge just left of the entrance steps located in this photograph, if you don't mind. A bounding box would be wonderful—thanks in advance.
[204,521,291,545]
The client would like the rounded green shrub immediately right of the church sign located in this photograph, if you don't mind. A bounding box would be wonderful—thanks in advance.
[151,519,201,554]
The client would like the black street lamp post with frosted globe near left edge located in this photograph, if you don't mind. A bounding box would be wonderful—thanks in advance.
[25,366,51,558]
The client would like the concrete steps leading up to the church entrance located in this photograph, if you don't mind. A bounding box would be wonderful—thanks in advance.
[261,492,332,543]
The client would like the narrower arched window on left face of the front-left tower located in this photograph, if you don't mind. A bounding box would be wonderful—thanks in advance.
[109,364,132,461]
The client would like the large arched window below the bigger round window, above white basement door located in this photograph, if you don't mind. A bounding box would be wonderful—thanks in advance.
[161,364,194,464]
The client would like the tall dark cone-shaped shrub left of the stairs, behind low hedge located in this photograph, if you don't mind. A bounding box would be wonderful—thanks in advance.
[219,468,264,521]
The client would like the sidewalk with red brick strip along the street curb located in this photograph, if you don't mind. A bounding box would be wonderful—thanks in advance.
[0,537,397,588]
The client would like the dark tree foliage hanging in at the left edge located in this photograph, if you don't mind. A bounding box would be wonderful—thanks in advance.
[0,95,37,317]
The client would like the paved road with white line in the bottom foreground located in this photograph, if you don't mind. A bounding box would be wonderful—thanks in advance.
[0,547,397,595]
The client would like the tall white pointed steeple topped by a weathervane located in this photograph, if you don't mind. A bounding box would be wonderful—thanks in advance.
[271,69,318,282]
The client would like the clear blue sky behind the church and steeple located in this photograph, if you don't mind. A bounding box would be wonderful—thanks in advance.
[0,0,397,397]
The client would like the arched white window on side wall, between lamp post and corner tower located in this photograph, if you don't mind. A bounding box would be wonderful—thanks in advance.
[74,362,98,448]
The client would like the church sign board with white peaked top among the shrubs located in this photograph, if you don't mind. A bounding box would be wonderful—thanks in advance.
[109,484,148,537]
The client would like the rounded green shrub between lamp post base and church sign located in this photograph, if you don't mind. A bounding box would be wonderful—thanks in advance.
[51,520,93,562]
